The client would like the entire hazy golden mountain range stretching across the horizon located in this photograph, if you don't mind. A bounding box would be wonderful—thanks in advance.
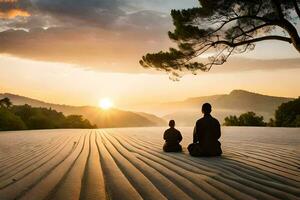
[0,90,293,128]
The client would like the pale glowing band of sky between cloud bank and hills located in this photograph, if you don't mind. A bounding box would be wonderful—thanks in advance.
[0,52,300,108]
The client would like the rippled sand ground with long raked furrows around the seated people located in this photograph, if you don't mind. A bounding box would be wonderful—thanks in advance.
[0,127,300,200]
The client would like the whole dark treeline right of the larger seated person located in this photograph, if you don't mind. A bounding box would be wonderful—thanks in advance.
[224,97,300,127]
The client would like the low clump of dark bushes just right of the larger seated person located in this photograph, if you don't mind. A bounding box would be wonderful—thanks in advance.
[224,112,266,126]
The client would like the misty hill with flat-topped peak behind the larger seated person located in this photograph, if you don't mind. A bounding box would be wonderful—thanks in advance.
[134,90,293,126]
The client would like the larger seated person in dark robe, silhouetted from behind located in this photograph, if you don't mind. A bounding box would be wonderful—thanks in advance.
[188,103,222,156]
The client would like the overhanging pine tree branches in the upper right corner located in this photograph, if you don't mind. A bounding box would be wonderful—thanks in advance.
[140,0,300,80]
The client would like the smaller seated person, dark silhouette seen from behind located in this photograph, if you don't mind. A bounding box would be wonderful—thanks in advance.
[163,120,182,152]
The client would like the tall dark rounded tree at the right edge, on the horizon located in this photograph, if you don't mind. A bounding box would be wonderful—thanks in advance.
[275,97,300,127]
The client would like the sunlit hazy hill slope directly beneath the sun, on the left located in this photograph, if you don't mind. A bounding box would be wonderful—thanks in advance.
[0,93,166,127]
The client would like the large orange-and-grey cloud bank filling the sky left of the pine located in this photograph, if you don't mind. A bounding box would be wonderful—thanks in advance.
[0,0,298,73]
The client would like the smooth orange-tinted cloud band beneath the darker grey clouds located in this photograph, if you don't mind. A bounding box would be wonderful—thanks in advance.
[0,16,169,72]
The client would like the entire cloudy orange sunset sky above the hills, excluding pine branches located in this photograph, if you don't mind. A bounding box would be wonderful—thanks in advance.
[0,0,300,108]
